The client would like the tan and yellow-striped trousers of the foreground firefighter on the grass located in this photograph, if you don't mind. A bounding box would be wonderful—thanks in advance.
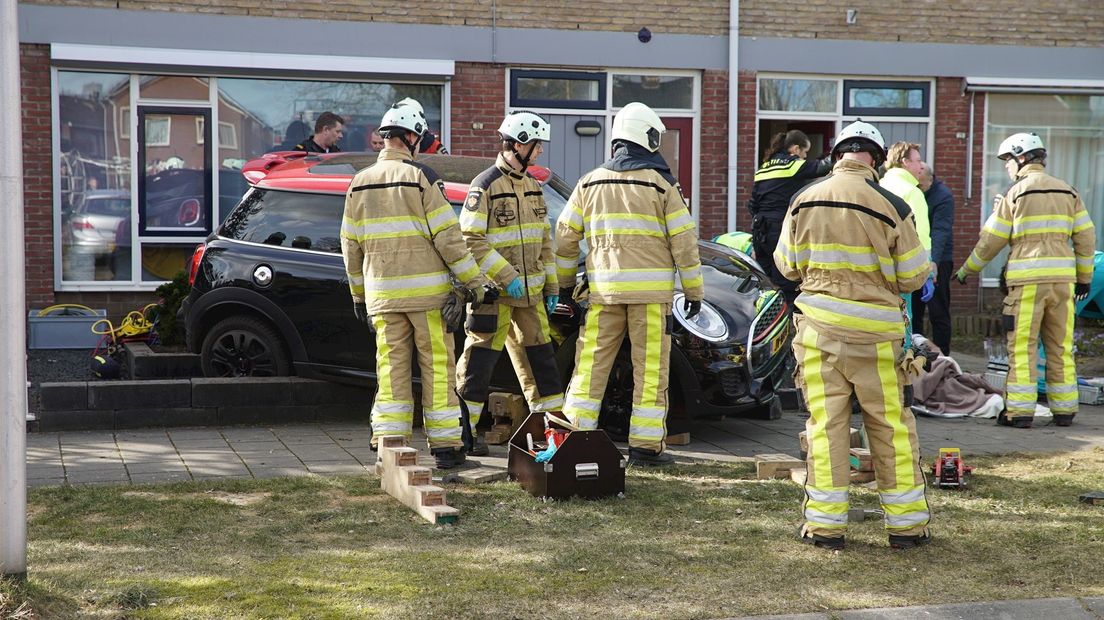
[794,317,931,537]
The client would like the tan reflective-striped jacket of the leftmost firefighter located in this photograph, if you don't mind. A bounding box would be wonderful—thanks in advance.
[341,148,486,314]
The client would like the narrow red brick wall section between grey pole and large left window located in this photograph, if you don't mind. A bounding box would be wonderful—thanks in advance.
[20,45,54,308]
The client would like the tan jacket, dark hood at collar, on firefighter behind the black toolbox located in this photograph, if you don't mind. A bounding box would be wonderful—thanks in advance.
[555,147,704,303]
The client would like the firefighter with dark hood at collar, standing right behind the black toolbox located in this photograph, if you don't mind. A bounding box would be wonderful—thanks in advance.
[556,101,704,466]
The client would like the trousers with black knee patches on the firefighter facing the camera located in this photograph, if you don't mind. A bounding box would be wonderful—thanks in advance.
[456,303,563,432]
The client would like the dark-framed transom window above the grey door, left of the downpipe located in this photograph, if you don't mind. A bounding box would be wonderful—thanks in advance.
[510,70,606,110]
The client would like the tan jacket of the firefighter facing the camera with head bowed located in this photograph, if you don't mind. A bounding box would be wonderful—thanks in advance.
[460,153,559,307]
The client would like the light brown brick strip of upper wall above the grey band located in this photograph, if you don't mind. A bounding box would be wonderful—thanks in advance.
[24,0,1104,47]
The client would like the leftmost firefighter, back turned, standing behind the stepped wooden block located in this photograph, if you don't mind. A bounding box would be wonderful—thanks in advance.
[341,99,487,469]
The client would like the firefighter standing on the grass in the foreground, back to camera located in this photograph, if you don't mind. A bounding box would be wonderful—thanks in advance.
[774,121,931,549]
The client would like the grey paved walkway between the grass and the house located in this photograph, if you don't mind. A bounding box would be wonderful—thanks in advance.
[26,356,1104,487]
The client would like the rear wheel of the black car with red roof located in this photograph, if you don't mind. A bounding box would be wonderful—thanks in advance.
[200,317,291,377]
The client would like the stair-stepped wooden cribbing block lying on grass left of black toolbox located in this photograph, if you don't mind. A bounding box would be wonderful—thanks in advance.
[378,441,460,524]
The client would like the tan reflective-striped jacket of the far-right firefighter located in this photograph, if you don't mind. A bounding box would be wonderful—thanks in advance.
[965,163,1096,286]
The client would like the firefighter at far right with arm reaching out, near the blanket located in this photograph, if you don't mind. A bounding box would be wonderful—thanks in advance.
[955,133,1096,428]
